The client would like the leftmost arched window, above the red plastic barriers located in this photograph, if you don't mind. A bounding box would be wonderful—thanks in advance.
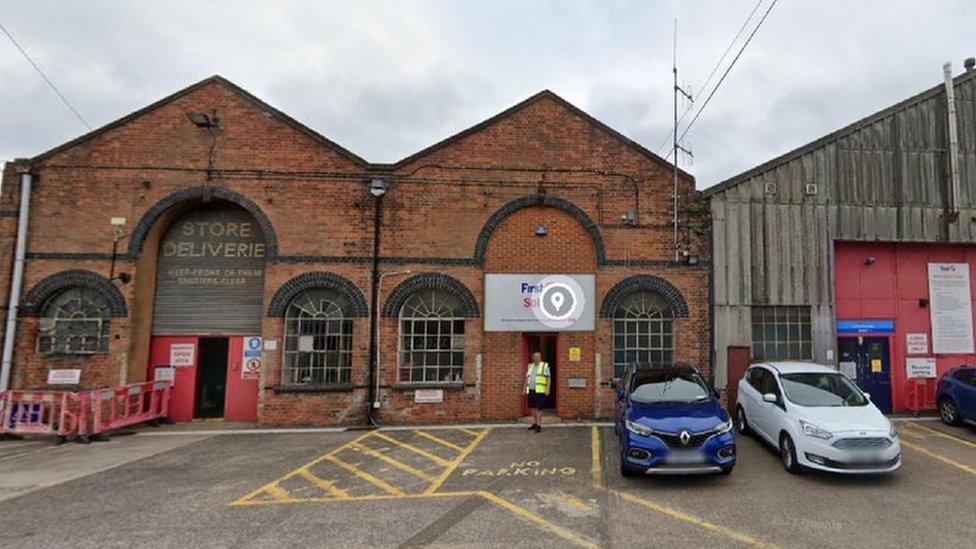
[37,286,112,355]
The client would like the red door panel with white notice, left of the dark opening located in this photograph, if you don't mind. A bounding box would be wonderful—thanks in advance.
[146,336,200,421]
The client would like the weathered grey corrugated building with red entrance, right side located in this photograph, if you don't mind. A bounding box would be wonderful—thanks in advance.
[705,60,976,411]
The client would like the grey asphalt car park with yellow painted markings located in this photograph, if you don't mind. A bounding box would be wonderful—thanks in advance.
[0,421,976,547]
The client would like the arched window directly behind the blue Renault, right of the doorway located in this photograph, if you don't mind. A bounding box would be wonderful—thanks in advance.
[613,291,674,377]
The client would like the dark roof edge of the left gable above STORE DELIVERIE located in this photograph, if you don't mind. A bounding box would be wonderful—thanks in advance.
[30,74,369,166]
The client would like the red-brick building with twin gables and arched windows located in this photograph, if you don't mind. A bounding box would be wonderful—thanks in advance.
[0,77,709,425]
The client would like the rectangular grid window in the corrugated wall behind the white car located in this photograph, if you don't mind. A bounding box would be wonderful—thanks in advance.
[752,305,813,360]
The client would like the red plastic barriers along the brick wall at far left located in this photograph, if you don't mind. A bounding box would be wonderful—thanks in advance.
[0,381,172,440]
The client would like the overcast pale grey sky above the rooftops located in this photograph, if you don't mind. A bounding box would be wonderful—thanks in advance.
[0,0,976,188]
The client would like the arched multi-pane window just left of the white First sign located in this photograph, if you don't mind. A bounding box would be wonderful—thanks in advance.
[399,289,464,383]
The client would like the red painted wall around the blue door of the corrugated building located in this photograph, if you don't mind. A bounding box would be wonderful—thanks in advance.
[835,242,976,412]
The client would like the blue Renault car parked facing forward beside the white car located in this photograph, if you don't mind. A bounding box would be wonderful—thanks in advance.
[614,364,735,477]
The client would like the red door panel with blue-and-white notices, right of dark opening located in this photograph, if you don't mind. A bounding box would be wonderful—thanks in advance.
[224,336,261,421]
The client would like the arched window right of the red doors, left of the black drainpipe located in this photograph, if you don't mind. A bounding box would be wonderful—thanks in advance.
[282,288,352,385]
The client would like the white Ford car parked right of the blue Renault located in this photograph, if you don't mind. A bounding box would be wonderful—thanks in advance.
[735,362,901,474]
